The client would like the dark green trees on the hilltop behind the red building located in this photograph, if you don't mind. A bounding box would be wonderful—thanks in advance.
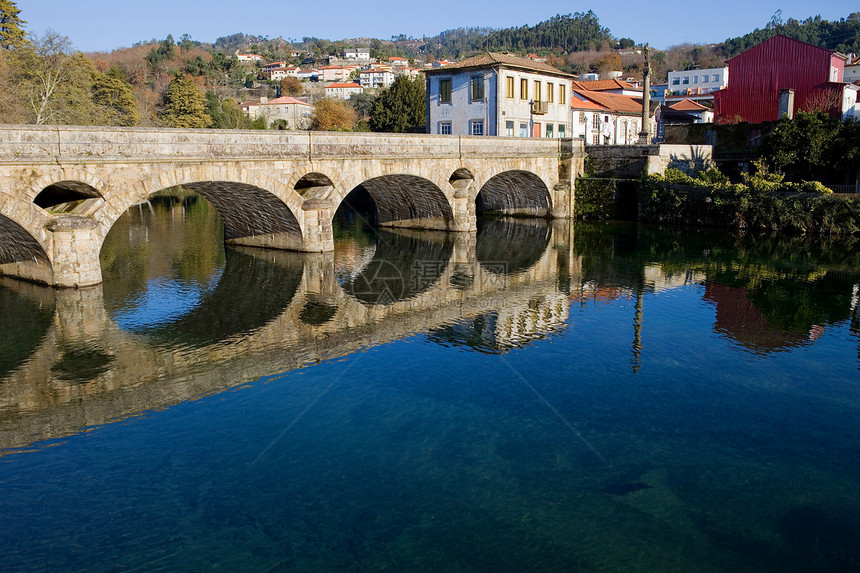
[724,12,860,58]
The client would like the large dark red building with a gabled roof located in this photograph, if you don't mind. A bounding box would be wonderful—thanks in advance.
[714,35,857,123]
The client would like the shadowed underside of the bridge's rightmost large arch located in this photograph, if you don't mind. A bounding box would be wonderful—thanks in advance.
[475,169,552,217]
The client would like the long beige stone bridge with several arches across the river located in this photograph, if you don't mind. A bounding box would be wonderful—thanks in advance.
[0,126,584,287]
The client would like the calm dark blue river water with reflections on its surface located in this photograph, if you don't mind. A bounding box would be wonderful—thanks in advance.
[0,194,860,572]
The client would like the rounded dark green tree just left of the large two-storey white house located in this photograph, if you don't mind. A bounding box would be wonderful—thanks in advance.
[370,76,427,133]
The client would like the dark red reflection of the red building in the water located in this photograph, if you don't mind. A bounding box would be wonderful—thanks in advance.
[705,282,821,353]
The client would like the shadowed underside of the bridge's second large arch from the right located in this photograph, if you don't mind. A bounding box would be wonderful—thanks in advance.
[335,174,455,231]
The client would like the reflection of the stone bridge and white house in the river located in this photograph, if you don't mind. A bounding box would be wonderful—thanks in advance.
[0,197,575,451]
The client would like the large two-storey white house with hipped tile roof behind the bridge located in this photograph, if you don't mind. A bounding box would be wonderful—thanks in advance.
[424,53,576,137]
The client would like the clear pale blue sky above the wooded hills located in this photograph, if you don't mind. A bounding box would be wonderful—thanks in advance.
[16,0,860,51]
